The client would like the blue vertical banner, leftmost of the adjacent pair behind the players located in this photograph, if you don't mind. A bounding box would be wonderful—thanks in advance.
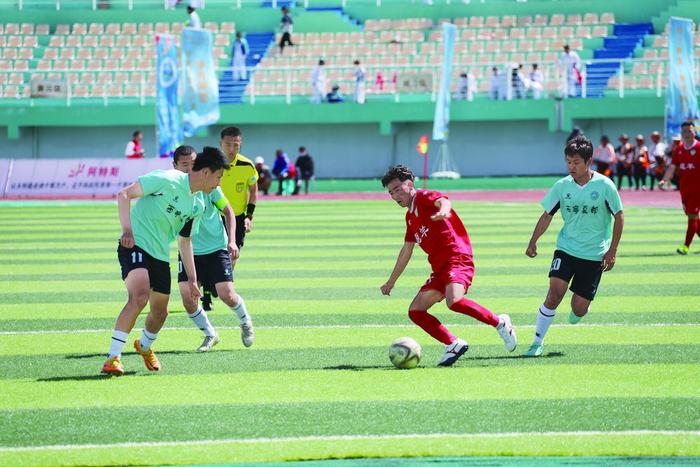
[156,34,182,157]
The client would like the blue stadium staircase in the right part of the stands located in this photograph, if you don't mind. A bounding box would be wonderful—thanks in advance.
[586,23,654,97]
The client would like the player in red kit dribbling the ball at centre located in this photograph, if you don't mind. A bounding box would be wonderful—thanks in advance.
[380,165,518,366]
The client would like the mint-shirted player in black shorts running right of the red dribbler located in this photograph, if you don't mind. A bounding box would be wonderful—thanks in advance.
[525,135,624,357]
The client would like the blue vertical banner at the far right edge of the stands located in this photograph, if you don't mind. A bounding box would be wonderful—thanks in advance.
[666,18,698,138]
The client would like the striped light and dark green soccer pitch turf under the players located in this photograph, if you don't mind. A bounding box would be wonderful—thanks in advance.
[0,200,700,465]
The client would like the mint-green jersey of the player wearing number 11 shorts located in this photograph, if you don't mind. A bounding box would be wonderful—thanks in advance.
[131,170,204,261]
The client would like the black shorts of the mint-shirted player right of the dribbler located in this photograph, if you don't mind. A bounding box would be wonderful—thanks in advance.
[549,250,603,300]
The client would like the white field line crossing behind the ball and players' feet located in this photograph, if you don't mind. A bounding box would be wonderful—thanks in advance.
[0,321,700,336]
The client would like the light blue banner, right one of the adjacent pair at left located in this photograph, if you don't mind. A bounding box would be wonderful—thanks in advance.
[182,28,219,137]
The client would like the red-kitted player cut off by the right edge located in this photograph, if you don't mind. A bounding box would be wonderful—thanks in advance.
[659,122,700,255]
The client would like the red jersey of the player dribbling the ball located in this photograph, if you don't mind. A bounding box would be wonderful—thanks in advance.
[404,190,472,271]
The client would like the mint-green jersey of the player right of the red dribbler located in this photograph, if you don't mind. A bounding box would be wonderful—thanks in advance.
[541,172,622,261]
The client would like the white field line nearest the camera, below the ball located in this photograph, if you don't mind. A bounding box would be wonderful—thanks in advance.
[0,430,700,452]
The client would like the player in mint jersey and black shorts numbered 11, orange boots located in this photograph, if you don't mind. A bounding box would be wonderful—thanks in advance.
[102,148,228,375]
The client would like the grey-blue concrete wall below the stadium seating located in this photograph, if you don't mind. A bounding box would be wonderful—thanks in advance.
[0,118,663,178]
